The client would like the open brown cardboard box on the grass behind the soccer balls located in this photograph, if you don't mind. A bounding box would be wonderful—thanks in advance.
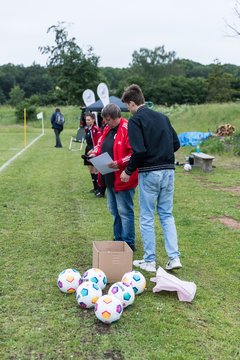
[92,240,133,283]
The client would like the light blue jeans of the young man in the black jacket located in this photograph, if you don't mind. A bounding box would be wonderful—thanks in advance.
[138,170,180,261]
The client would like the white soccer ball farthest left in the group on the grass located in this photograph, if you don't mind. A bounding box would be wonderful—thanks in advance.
[57,269,81,293]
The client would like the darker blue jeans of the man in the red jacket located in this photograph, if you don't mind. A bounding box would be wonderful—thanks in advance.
[107,187,135,245]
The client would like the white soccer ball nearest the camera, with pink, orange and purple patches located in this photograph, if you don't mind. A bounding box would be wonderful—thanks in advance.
[94,295,123,324]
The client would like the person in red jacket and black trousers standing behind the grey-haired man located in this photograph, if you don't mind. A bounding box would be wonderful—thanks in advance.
[82,113,102,193]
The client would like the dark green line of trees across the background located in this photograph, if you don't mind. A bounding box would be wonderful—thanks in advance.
[0,23,240,114]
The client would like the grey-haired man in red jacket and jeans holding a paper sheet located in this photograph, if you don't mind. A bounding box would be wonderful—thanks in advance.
[90,104,138,251]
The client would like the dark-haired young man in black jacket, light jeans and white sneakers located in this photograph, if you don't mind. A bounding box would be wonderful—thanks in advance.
[121,84,182,272]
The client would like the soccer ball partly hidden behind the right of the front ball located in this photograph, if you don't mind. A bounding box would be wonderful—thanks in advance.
[108,281,135,308]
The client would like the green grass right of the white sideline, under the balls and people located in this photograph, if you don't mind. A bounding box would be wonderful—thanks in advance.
[0,104,240,360]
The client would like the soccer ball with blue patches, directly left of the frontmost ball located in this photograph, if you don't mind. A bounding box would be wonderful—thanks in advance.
[76,281,102,309]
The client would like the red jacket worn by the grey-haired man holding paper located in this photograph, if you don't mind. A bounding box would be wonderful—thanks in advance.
[93,118,138,192]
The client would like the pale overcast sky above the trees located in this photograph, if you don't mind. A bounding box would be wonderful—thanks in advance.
[0,0,240,68]
